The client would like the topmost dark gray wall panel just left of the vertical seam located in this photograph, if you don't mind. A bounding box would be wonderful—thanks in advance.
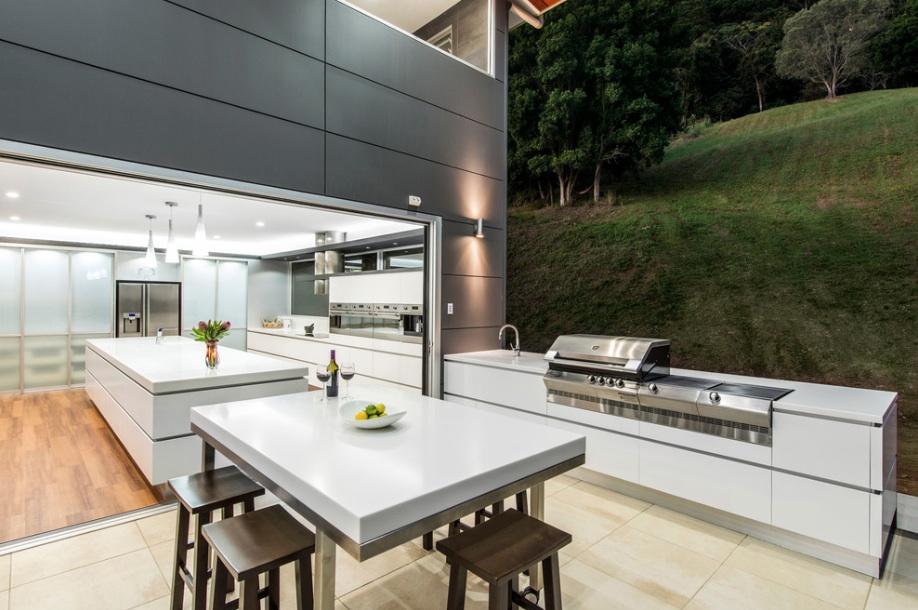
[170,0,325,59]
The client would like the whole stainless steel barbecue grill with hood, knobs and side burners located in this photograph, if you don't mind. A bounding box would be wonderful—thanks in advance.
[544,335,792,446]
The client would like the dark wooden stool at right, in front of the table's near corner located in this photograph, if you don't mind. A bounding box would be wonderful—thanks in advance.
[437,508,571,610]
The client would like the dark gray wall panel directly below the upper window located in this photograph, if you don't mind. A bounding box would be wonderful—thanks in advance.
[326,0,504,129]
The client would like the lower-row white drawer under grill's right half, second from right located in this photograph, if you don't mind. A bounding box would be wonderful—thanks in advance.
[640,441,771,523]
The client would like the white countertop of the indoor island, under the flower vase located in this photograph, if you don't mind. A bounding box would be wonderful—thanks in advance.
[86,337,309,394]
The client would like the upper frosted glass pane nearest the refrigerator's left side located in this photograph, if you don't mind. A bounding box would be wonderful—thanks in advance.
[70,252,113,333]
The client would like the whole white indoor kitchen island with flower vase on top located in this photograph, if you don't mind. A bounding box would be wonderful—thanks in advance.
[86,337,309,485]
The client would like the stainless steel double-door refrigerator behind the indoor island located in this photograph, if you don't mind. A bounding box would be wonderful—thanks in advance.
[115,280,182,337]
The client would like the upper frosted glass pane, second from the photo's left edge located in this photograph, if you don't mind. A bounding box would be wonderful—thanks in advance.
[23,248,70,332]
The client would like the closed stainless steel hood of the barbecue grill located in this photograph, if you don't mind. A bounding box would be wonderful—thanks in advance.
[545,335,670,381]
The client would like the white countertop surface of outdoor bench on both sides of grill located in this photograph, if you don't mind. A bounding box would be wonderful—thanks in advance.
[443,350,897,424]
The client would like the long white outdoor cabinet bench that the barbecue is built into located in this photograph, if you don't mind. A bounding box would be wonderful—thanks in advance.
[443,350,897,576]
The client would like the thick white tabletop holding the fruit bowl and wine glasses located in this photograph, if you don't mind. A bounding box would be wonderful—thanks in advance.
[191,386,586,544]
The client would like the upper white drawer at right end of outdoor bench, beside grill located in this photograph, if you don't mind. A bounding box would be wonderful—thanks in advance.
[772,412,868,488]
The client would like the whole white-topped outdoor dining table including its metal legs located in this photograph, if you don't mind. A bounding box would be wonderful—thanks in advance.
[191,384,586,610]
